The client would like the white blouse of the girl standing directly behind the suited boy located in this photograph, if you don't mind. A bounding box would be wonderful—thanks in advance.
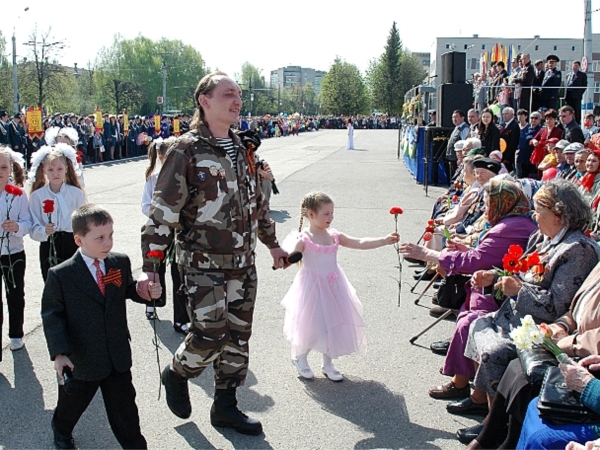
[29,183,87,242]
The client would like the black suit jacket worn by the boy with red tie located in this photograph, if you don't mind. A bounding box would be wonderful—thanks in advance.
[42,252,146,381]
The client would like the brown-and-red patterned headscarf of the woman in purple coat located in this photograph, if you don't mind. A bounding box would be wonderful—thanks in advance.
[486,178,531,226]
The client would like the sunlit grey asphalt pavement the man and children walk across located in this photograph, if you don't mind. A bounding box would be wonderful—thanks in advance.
[0,130,478,449]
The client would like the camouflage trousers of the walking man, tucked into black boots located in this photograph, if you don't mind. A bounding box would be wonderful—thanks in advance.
[173,266,257,389]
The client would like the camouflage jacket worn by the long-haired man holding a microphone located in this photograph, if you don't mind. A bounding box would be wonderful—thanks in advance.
[142,125,279,272]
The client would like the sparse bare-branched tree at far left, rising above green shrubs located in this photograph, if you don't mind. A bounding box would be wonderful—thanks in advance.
[19,27,65,106]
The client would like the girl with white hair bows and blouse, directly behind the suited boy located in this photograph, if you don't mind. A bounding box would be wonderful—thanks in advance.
[28,143,87,281]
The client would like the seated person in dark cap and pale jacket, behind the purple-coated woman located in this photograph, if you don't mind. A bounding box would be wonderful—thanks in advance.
[418,156,501,279]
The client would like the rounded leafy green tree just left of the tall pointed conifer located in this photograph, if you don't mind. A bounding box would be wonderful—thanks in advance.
[321,56,368,115]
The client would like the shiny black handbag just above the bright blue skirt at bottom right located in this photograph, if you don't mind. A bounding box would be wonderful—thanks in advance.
[537,367,600,425]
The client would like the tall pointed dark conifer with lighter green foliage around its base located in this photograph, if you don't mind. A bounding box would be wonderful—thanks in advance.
[367,22,426,114]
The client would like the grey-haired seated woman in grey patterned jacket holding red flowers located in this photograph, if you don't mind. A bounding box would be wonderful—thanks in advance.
[449,179,600,441]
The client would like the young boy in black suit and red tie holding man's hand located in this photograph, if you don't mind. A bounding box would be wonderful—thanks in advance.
[42,205,162,449]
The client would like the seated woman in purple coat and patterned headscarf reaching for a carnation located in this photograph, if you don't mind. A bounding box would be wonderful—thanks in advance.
[399,179,536,403]
